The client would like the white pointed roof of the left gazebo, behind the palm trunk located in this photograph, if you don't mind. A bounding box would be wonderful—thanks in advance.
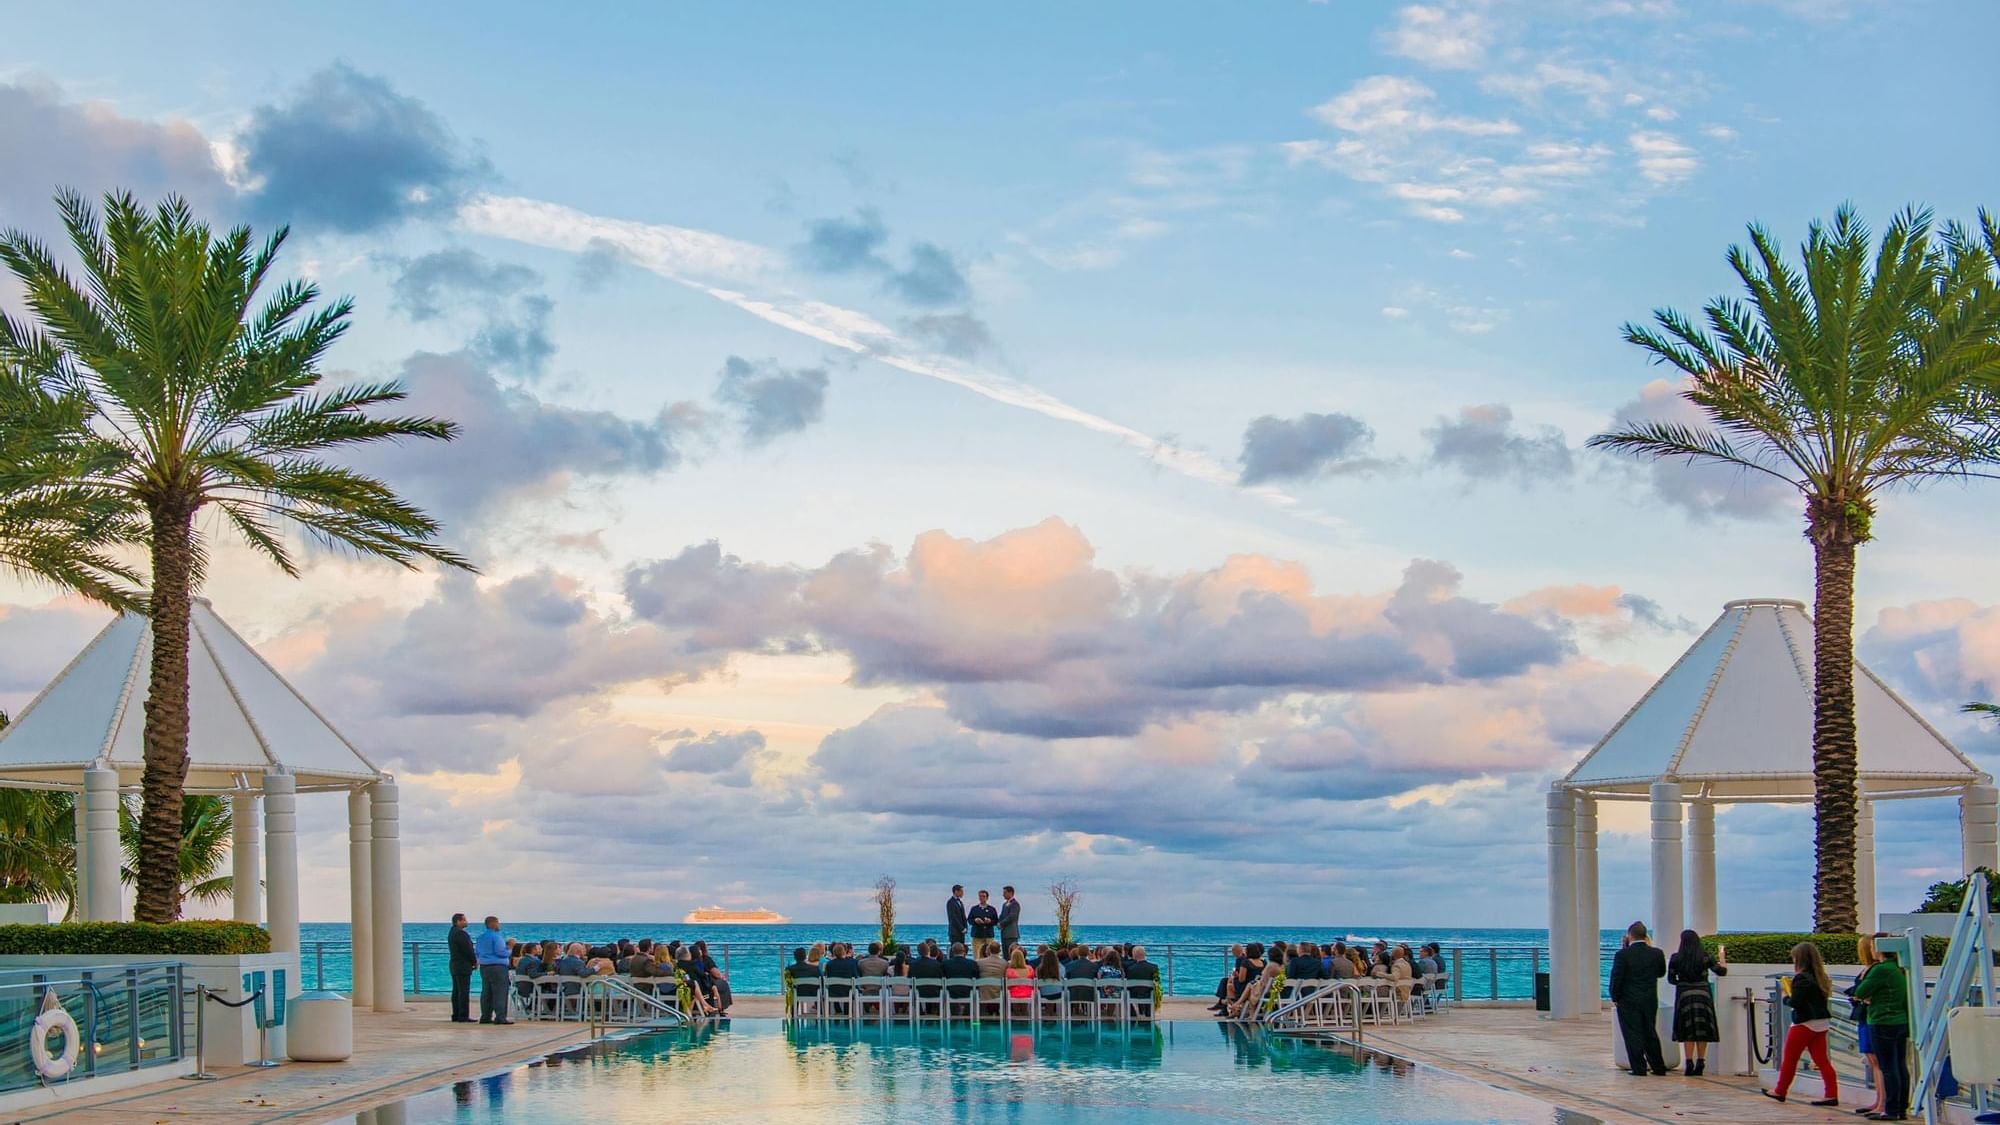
[0,599,382,793]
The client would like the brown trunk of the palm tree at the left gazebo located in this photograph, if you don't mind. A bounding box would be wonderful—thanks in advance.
[136,496,194,923]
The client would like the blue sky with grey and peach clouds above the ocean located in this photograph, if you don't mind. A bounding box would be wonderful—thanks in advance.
[0,0,2000,929]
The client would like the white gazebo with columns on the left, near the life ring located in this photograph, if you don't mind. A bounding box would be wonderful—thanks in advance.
[0,599,404,1011]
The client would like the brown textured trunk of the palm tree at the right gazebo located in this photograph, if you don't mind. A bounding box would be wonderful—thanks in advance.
[1806,500,1862,933]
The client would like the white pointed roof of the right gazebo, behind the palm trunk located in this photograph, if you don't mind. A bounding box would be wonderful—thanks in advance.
[1560,599,1988,801]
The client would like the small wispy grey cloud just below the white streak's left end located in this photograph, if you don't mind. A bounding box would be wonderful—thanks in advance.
[386,248,556,378]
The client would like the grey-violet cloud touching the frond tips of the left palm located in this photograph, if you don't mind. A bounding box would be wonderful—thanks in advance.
[348,352,700,522]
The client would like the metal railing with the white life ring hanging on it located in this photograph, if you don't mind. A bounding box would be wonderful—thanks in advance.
[0,961,188,1091]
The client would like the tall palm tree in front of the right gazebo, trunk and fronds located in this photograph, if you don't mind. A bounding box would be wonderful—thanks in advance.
[1590,206,2000,933]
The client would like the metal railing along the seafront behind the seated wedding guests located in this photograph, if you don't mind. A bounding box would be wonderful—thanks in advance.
[300,941,1592,1001]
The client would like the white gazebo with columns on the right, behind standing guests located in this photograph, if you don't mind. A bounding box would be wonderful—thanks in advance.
[1548,599,2000,1019]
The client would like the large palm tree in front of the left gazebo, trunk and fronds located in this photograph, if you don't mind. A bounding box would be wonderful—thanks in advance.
[0,192,470,923]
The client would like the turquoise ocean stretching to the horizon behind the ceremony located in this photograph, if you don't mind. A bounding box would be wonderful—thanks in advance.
[298,919,1620,999]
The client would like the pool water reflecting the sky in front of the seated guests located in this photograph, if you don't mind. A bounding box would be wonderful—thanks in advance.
[354,1019,1596,1125]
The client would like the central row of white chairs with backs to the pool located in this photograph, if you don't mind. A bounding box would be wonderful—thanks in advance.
[790,977,1156,1025]
